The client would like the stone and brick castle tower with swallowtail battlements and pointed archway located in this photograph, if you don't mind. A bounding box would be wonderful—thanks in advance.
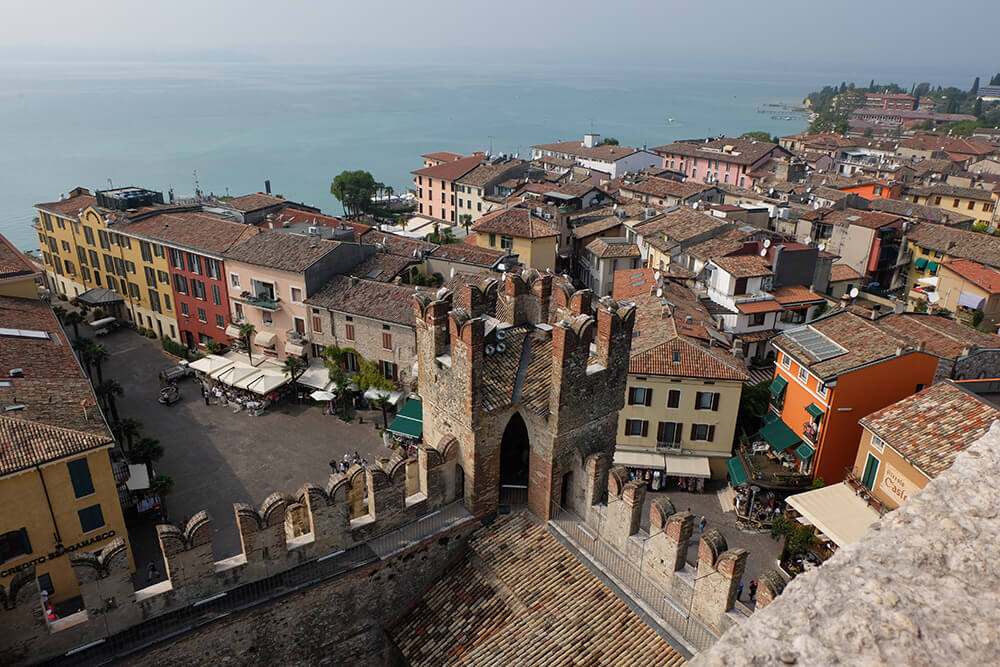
[414,269,635,519]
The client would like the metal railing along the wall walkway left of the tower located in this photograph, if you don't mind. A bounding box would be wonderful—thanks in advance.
[48,500,472,666]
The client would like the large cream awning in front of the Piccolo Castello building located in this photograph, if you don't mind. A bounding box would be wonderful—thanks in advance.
[787,482,879,547]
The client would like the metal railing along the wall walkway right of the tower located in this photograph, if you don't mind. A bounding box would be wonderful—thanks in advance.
[549,503,718,653]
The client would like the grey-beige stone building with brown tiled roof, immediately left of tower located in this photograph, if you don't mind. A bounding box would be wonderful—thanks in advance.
[306,276,417,382]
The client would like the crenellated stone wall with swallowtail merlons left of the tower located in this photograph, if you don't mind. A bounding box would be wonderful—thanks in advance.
[0,446,474,664]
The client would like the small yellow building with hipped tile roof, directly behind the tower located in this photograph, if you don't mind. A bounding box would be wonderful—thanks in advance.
[472,206,559,271]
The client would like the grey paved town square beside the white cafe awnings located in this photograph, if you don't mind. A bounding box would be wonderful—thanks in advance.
[97,330,390,576]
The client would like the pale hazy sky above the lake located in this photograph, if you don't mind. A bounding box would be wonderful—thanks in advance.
[0,0,1000,76]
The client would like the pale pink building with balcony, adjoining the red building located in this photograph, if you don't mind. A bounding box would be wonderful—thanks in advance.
[224,231,374,359]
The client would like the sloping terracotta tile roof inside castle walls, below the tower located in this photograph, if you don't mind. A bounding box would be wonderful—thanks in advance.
[389,513,684,667]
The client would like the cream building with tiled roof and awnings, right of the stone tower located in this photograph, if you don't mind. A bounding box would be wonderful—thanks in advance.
[614,268,748,479]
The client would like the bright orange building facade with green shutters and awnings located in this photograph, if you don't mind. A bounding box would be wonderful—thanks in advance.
[762,343,937,484]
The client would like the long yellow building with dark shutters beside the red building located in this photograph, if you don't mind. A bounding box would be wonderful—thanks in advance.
[35,188,180,341]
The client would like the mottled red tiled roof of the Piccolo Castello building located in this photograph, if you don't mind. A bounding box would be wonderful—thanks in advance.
[858,380,1000,477]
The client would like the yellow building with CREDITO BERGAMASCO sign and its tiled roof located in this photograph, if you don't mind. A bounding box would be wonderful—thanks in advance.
[0,296,134,616]
